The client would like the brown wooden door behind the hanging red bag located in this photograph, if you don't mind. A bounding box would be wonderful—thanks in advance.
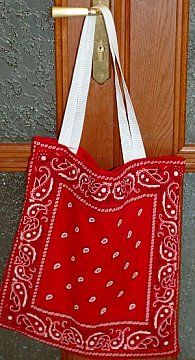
[0,0,195,360]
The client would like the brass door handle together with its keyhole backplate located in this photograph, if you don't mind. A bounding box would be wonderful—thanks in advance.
[52,0,110,84]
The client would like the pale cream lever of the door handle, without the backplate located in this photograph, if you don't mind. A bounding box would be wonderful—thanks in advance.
[51,6,101,18]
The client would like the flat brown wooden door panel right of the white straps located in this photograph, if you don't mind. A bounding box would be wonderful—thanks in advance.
[127,0,177,156]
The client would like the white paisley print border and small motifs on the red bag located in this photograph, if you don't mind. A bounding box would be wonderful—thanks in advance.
[0,138,184,358]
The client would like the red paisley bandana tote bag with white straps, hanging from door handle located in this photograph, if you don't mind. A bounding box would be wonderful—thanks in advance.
[0,6,184,358]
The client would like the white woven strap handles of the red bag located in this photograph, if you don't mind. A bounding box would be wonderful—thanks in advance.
[59,5,146,163]
